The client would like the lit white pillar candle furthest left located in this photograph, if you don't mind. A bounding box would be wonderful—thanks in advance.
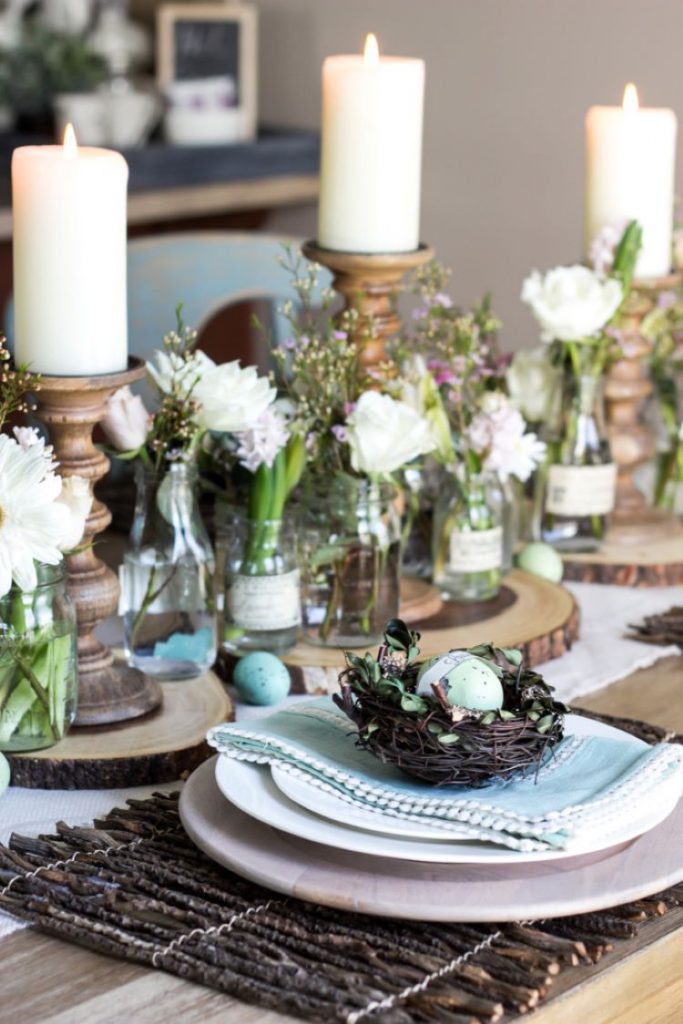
[12,129,128,377]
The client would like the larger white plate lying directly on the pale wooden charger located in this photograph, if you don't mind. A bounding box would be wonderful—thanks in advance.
[216,729,676,864]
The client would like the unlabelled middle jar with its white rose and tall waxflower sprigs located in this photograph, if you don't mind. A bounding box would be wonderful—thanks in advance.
[274,254,437,646]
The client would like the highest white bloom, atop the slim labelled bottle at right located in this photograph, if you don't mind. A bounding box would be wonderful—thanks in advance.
[521,265,624,341]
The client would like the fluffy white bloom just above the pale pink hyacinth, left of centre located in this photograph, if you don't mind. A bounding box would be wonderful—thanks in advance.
[193,359,276,433]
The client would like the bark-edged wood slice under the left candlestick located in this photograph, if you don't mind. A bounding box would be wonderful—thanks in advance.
[7,672,234,790]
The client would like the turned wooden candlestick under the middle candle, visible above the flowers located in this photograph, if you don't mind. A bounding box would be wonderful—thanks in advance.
[302,242,434,369]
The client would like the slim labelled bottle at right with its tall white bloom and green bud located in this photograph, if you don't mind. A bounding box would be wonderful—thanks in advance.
[521,221,641,551]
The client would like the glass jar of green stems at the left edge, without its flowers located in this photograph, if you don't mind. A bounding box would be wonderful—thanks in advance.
[0,565,78,753]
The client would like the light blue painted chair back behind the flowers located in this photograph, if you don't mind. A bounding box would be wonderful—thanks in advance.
[128,231,331,359]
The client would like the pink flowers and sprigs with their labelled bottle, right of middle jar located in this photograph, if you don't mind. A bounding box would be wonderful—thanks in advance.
[410,263,545,601]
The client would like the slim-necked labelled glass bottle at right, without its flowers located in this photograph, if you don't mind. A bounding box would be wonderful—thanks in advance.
[541,371,616,552]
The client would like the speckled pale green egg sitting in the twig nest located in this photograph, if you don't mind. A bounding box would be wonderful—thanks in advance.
[417,650,504,711]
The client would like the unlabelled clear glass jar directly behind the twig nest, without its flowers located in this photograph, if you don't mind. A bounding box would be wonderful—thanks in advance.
[299,476,400,647]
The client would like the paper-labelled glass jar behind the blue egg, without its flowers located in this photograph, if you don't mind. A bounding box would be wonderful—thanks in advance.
[216,509,301,654]
